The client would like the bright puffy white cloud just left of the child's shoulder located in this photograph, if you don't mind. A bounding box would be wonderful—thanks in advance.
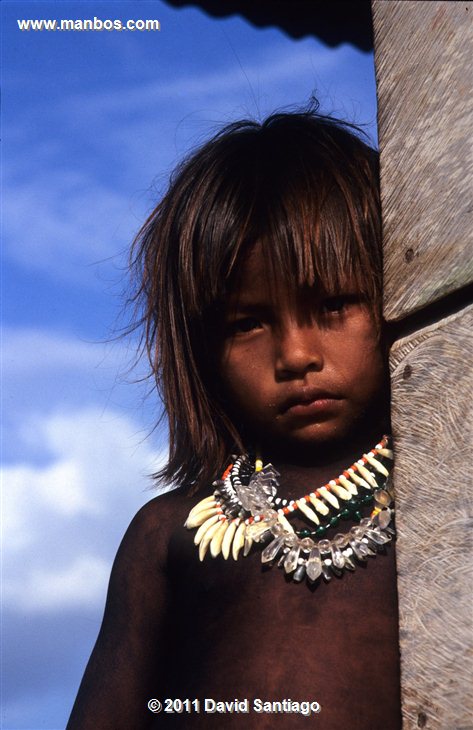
[2,408,163,612]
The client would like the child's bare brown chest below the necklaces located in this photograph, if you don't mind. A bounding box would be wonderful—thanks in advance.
[157,529,401,730]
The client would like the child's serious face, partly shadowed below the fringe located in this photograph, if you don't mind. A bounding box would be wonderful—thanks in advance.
[219,246,386,450]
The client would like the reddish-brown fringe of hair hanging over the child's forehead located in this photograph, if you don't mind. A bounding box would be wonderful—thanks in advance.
[251,156,381,307]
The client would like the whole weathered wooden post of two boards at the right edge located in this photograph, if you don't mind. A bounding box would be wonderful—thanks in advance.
[372,0,473,730]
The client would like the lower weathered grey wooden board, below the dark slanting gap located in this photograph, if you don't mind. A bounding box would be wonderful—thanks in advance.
[390,306,473,730]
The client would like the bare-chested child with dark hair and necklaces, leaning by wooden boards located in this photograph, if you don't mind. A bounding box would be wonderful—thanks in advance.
[68,105,401,730]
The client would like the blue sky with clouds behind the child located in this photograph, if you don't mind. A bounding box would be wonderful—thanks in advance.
[1,0,376,730]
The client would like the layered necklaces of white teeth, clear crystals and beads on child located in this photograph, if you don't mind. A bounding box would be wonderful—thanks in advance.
[185,436,395,582]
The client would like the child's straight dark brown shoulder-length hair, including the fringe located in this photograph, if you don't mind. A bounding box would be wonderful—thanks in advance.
[132,110,382,489]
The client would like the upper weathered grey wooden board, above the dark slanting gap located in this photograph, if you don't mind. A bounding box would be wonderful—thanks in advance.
[372,0,473,320]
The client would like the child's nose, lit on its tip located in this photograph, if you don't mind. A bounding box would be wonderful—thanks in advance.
[276,321,323,378]
